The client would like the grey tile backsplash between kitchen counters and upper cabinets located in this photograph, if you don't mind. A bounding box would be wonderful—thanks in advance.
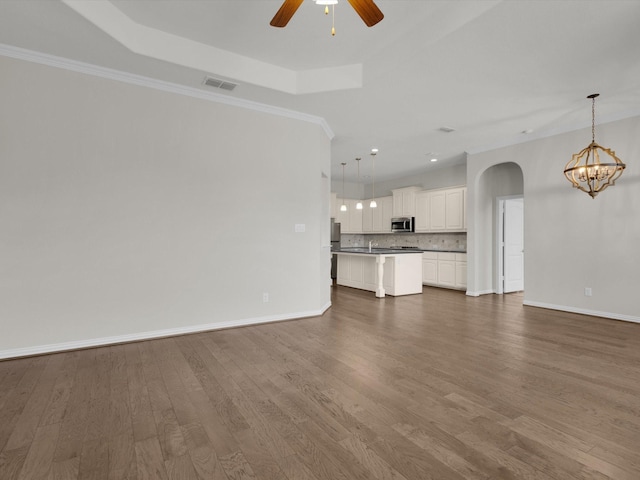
[340,233,467,252]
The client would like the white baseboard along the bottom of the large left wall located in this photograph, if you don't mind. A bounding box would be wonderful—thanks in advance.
[0,302,331,360]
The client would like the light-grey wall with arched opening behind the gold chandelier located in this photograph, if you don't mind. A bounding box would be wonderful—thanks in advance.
[467,117,640,321]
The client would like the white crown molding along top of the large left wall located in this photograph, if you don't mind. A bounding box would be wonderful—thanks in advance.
[0,44,334,140]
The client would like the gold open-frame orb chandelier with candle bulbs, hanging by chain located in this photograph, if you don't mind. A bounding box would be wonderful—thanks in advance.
[564,93,626,198]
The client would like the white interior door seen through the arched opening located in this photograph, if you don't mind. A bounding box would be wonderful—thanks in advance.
[504,198,524,293]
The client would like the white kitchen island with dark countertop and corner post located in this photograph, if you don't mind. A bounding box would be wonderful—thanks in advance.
[333,247,422,298]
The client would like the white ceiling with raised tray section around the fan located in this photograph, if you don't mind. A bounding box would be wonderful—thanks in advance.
[0,0,640,181]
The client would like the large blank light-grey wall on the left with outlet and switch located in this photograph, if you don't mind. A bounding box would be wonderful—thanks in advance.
[0,57,330,357]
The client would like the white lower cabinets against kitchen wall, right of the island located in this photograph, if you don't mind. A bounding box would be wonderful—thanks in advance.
[422,252,467,290]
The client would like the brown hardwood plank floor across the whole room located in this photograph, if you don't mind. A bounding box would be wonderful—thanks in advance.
[0,287,640,480]
